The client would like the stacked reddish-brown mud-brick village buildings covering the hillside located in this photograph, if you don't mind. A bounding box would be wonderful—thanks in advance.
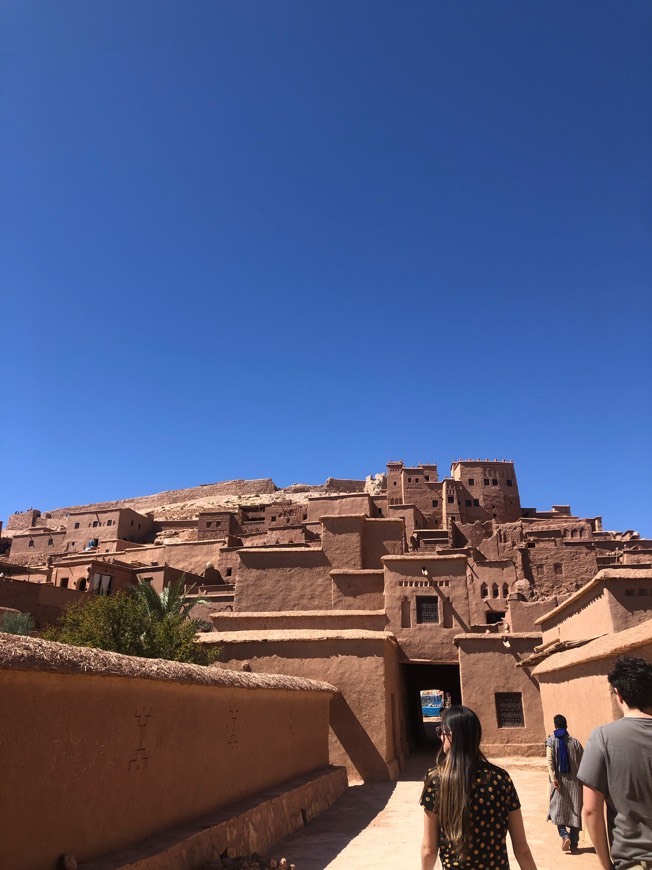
[0,459,652,779]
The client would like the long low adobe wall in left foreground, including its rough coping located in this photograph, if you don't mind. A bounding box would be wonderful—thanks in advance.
[0,635,335,870]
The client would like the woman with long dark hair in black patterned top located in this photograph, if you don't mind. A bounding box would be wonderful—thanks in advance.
[421,707,537,870]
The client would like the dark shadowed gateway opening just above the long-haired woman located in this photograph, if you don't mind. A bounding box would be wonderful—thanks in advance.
[401,662,462,752]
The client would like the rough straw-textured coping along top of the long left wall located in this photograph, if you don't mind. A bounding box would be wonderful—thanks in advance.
[0,632,338,693]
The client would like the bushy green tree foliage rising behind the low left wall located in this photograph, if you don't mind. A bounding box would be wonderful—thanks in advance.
[44,583,218,665]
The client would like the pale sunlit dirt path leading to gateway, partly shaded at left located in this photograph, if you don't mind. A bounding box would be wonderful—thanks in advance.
[273,755,598,870]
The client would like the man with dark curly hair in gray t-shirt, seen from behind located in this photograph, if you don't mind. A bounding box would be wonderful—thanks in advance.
[577,657,652,870]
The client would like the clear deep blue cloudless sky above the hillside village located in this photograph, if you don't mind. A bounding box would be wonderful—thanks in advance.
[0,0,652,535]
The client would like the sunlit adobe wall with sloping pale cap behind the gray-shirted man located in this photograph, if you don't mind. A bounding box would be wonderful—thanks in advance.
[532,619,652,745]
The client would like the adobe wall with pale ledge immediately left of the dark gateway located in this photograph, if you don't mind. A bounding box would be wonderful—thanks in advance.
[206,629,405,781]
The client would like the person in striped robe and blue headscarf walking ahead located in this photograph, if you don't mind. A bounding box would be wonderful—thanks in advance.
[546,713,584,852]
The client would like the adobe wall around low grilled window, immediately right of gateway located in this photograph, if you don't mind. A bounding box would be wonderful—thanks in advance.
[455,633,546,757]
